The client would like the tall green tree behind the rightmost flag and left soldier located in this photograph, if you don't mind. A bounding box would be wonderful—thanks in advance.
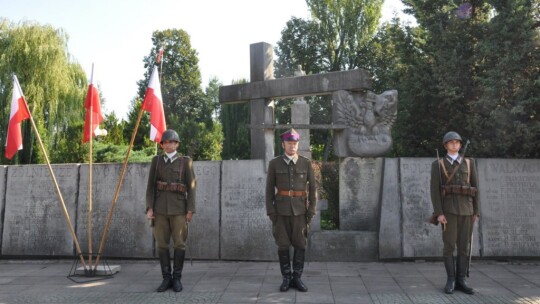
[130,29,222,160]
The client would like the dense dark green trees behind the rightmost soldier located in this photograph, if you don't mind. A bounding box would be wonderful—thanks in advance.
[396,0,540,157]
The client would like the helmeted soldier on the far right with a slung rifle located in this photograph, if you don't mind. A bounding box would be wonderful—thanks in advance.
[431,132,480,294]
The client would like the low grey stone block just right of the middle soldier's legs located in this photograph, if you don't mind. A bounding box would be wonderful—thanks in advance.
[306,231,377,262]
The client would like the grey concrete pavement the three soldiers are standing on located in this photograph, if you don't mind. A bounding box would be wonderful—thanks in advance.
[0,260,540,304]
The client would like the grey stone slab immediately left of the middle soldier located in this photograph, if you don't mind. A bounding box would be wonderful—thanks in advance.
[220,160,277,260]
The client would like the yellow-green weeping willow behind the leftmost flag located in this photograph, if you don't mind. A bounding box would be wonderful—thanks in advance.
[0,19,87,164]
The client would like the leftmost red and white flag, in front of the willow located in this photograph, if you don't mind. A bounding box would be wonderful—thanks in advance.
[6,75,31,159]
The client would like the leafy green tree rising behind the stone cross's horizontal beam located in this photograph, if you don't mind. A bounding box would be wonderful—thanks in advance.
[275,0,383,160]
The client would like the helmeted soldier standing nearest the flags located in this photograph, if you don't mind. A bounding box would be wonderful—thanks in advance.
[146,130,196,292]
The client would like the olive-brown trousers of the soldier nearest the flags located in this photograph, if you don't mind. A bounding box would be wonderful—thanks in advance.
[152,214,188,250]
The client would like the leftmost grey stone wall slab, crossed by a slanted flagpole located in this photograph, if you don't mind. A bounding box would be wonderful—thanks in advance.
[2,164,79,256]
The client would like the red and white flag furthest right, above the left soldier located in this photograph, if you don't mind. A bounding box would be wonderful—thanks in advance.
[142,66,167,142]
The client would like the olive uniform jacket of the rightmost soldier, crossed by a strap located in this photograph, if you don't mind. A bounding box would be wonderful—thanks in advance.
[430,155,480,216]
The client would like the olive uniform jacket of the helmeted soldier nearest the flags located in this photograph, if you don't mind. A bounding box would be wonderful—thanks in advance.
[146,155,196,215]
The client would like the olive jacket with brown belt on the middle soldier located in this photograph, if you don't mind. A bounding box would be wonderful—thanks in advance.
[266,155,317,216]
